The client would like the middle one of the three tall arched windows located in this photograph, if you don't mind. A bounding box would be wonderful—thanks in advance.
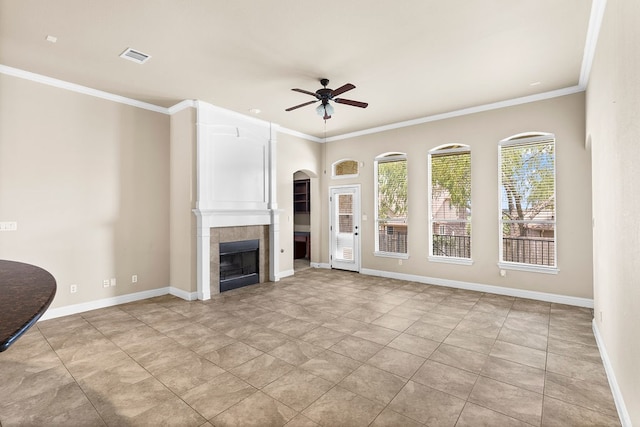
[428,144,471,263]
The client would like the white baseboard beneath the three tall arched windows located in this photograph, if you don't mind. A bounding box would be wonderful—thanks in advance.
[360,268,593,308]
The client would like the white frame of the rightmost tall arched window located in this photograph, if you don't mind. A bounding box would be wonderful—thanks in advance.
[498,132,560,274]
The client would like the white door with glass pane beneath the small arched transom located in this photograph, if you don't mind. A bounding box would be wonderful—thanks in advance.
[329,185,360,272]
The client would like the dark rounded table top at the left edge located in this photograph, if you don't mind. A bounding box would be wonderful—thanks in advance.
[0,260,57,351]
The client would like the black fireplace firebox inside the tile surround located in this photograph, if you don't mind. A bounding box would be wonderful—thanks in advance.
[220,239,260,292]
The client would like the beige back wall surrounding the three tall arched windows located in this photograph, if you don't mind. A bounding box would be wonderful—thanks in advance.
[321,93,593,298]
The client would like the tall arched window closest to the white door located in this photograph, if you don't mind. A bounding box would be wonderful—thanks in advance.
[375,153,408,258]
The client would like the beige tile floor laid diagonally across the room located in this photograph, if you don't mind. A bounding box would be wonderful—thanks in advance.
[0,268,620,427]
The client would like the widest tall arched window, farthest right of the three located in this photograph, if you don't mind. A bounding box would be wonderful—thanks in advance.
[498,132,557,272]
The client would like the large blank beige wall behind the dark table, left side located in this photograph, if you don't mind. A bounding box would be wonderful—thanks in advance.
[0,74,169,307]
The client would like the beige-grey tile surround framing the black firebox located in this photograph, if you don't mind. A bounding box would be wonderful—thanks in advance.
[209,225,269,295]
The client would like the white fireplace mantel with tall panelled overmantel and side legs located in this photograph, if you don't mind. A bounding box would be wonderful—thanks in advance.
[193,101,280,300]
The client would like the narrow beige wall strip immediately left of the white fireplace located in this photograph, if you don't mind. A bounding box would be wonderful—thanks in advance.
[169,108,198,293]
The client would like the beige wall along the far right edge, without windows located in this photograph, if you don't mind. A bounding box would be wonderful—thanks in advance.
[587,0,640,425]
